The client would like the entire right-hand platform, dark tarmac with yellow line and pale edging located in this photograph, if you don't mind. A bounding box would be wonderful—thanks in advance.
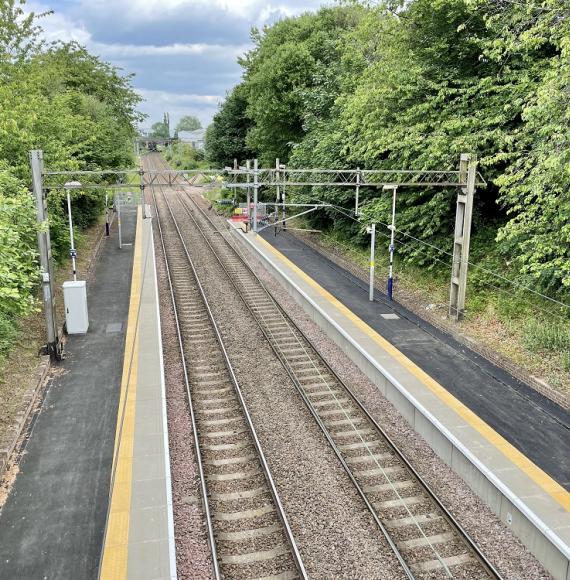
[230,228,570,580]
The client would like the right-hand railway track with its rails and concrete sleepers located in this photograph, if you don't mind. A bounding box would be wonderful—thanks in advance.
[160,173,500,579]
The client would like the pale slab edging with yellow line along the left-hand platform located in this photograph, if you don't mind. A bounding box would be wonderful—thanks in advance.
[100,214,176,580]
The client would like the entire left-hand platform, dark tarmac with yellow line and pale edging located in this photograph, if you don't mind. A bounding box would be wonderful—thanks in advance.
[0,208,175,580]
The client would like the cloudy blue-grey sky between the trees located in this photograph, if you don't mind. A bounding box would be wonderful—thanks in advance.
[26,0,326,128]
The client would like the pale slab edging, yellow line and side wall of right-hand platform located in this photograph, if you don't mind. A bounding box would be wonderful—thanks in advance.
[234,225,570,580]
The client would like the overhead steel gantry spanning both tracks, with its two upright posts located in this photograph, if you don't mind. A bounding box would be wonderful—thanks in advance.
[34,151,480,357]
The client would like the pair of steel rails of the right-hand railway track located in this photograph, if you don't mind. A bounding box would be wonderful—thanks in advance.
[174,182,500,578]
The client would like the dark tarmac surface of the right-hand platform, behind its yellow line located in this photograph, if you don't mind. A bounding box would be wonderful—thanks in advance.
[261,229,570,491]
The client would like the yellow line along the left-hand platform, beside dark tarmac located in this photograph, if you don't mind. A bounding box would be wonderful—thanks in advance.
[99,207,142,580]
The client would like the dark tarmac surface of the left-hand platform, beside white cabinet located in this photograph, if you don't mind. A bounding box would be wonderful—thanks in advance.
[0,206,136,580]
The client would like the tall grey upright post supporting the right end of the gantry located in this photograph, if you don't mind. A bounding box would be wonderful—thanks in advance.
[449,153,477,321]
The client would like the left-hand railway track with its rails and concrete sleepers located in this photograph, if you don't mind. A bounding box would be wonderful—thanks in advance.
[146,161,306,580]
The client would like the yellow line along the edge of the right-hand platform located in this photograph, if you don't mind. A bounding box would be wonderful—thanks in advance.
[256,236,570,511]
